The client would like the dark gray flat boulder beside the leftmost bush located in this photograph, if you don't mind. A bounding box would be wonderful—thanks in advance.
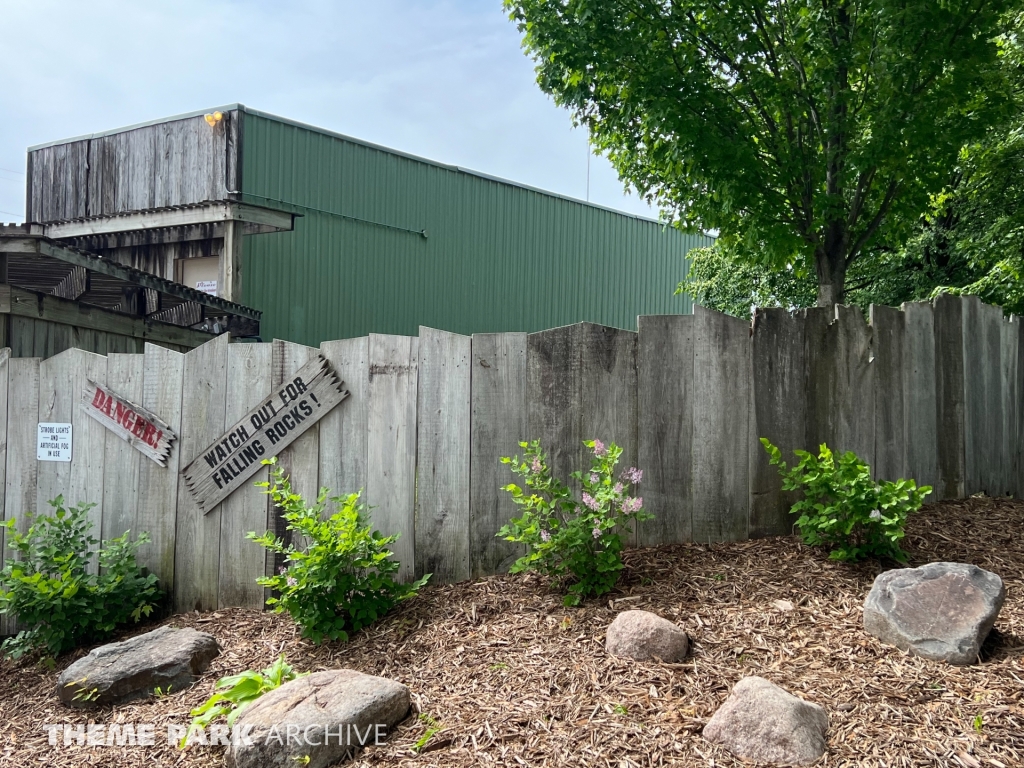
[57,627,220,707]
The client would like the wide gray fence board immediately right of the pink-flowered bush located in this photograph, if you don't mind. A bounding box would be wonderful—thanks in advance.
[638,314,693,547]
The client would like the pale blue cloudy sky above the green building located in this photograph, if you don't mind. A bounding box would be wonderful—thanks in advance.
[0,0,656,221]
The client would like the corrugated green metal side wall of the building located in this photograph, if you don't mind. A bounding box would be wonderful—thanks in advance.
[237,113,712,345]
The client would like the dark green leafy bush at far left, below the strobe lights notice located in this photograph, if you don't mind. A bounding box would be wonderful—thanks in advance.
[0,496,161,658]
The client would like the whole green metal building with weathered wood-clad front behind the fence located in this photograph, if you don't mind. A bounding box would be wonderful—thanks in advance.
[28,104,712,345]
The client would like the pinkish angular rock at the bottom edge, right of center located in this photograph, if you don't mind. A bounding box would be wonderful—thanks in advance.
[703,677,828,765]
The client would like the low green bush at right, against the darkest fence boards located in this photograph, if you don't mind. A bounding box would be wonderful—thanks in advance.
[761,437,932,562]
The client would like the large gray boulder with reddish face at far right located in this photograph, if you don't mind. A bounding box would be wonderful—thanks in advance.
[864,562,1007,665]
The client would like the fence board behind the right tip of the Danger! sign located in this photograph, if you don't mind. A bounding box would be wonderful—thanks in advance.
[137,344,185,590]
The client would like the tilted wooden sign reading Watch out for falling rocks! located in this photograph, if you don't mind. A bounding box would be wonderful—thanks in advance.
[181,354,348,514]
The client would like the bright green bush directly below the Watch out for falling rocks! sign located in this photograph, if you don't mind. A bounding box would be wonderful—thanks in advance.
[248,459,430,643]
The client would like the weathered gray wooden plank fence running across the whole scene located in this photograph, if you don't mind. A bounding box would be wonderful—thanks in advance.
[0,297,1024,626]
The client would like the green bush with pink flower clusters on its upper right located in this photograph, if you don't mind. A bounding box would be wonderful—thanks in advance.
[498,440,653,605]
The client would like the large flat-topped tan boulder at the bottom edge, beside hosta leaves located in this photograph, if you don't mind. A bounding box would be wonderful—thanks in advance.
[225,670,410,768]
